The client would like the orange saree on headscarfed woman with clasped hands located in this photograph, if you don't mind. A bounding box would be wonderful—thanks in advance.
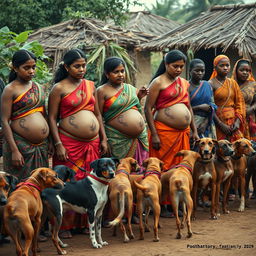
[214,78,245,142]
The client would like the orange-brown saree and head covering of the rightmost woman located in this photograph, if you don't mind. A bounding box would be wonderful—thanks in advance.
[231,59,256,141]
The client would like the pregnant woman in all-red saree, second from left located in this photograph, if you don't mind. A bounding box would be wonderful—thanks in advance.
[49,49,107,238]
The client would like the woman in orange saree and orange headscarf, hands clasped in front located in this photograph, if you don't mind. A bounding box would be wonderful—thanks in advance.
[209,55,245,142]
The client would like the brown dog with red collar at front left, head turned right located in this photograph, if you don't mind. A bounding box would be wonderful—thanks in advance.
[4,168,64,256]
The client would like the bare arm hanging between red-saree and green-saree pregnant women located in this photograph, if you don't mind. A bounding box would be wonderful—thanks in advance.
[94,88,108,155]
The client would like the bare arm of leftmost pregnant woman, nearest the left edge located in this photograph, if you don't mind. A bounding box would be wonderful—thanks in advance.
[1,86,24,166]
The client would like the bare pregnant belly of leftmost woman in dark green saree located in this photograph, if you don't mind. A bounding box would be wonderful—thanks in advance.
[11,112,49,144]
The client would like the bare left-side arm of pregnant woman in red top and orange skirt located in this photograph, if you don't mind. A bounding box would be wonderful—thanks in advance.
[144,81,161,150]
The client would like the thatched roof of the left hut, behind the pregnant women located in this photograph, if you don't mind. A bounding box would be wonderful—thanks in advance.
[29,18,153,65]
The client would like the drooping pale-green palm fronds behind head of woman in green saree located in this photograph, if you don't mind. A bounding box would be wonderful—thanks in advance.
[87,42,136,86]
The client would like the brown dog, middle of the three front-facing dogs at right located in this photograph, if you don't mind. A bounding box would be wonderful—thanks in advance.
[214,140,234,215]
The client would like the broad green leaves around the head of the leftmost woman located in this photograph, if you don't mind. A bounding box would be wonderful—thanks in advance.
[0,27,52,84]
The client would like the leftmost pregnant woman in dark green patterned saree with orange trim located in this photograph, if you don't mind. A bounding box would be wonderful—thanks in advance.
[1,50,49,180]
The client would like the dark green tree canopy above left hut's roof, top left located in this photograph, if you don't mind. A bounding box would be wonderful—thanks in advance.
[0,0,139,33]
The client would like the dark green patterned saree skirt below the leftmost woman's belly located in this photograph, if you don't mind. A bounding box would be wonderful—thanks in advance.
[3,133,49,181]
